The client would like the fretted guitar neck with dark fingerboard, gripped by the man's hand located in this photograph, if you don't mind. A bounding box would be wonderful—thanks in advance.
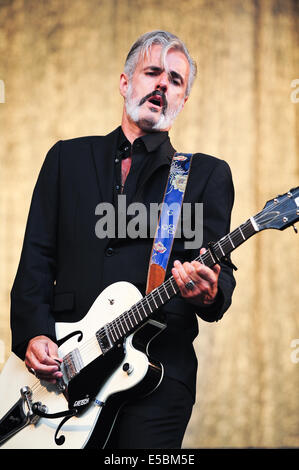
[96,217,259,351]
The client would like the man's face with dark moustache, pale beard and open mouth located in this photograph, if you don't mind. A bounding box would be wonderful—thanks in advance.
[120,45,189,132]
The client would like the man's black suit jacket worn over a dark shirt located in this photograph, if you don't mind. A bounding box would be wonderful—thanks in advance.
[11,128,235,396]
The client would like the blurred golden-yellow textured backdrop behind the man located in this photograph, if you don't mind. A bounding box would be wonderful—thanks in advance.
[0,0,299,447]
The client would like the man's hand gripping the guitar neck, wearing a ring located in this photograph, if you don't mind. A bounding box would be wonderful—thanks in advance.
[172,248,221,306]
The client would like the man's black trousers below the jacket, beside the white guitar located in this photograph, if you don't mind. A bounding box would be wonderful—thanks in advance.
[105,376,194,449]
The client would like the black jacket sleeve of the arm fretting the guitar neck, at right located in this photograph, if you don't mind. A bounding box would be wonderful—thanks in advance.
[197,160,236,322]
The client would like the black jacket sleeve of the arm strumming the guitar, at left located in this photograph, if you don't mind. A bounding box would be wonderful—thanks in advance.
[11,142,60,359]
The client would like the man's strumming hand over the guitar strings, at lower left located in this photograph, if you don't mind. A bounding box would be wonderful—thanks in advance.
[25,336,62,383]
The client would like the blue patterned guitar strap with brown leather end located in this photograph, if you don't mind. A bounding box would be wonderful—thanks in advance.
[146,153,193,294]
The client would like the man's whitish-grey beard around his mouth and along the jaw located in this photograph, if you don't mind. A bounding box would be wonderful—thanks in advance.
[125,82,184,132]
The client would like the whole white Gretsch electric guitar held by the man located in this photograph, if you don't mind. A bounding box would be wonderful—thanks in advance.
[0,187,299,449]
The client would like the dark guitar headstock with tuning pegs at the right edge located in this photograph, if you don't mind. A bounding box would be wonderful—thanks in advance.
[253,186,299,230]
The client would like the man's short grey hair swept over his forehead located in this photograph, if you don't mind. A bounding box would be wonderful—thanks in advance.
[124,30,197,96]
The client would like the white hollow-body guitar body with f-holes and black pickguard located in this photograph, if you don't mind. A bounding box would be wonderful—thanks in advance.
[0,282,165,449]
